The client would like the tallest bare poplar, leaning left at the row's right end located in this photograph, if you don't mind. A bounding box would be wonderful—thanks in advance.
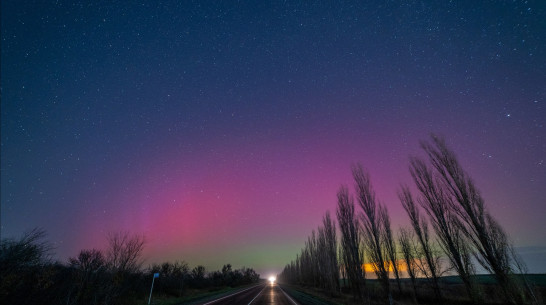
[421,135,523,304]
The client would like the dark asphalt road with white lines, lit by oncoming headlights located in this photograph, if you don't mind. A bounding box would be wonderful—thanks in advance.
[198,283,299,305]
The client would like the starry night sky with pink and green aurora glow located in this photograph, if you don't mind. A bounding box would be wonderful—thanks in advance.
[1,0,546,275]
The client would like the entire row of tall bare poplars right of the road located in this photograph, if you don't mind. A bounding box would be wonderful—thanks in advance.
[279,135,538,304]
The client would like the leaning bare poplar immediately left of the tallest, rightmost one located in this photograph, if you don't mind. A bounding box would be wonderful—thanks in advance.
[410,158,480,304]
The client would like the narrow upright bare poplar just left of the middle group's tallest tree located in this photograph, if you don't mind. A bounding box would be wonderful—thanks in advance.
[336,186,365,299]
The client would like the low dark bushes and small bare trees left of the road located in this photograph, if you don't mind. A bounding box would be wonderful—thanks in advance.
[0,229,260,305]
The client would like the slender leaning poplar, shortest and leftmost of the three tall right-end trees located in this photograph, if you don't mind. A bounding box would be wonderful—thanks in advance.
[398,186,442,301]
